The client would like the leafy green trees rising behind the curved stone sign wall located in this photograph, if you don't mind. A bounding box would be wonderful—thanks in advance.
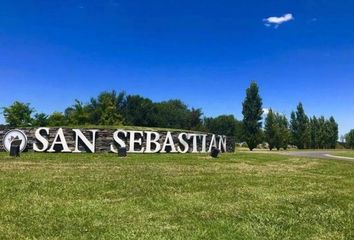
[3,91,242,140]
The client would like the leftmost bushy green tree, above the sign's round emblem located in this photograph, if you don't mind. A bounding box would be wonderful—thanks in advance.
[3,101,34,127]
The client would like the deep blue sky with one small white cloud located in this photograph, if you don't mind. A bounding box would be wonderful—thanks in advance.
[0,0,354,134]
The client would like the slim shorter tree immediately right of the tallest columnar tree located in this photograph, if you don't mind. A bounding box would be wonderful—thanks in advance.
[264,109,280,151]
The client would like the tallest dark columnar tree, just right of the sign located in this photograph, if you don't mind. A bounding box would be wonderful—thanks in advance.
[242,82,263,151]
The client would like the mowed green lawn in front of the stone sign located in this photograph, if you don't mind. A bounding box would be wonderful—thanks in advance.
[0,152,354,239]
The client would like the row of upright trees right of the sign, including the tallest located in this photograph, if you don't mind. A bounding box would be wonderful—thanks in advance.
[242,82,338,150]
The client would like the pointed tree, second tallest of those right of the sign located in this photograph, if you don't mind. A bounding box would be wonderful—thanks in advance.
[290,103,310,149]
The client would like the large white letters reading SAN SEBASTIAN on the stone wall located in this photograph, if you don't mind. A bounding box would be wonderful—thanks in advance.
[33,127,227,153]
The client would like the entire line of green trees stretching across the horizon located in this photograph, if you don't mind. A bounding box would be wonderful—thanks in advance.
[3,82,348,150]
